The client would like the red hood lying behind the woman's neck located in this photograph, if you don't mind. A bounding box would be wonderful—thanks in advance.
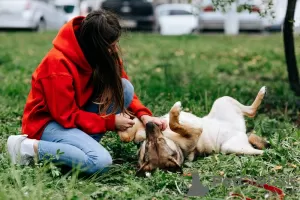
[53,16,92,72]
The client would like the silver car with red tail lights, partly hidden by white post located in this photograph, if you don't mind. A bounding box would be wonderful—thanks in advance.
[199,0,264,31]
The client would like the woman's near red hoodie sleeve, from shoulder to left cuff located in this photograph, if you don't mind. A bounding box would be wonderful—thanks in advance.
[40,75,115,134]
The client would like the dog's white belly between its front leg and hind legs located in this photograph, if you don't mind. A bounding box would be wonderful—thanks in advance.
[197,118,244,154]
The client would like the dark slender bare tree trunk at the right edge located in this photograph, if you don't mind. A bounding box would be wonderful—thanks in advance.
[283,0,300,96]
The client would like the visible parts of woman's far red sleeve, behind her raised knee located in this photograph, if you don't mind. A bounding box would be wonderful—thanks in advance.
[122,68,152,119]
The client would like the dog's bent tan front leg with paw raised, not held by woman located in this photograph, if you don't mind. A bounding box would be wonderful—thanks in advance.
[169,101,202,138]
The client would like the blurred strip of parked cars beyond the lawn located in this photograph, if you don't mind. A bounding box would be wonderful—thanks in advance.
[0,0,300,35]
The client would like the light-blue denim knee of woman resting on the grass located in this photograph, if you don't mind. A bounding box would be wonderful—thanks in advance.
[86,148,113,174]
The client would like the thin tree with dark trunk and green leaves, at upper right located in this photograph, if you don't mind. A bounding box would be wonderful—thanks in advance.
[212,0,300,96]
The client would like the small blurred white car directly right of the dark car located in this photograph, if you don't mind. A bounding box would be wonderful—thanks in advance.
[155,4,199,35]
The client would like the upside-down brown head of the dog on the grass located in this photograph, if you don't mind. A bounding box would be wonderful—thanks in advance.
[136,122,184,176]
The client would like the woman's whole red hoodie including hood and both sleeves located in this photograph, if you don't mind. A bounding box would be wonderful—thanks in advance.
[22,17,152,139]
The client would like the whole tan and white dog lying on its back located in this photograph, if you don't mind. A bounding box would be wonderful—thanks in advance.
[118,87,268,171]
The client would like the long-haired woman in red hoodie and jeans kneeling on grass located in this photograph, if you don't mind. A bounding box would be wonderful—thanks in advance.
[7,10,166,174]
